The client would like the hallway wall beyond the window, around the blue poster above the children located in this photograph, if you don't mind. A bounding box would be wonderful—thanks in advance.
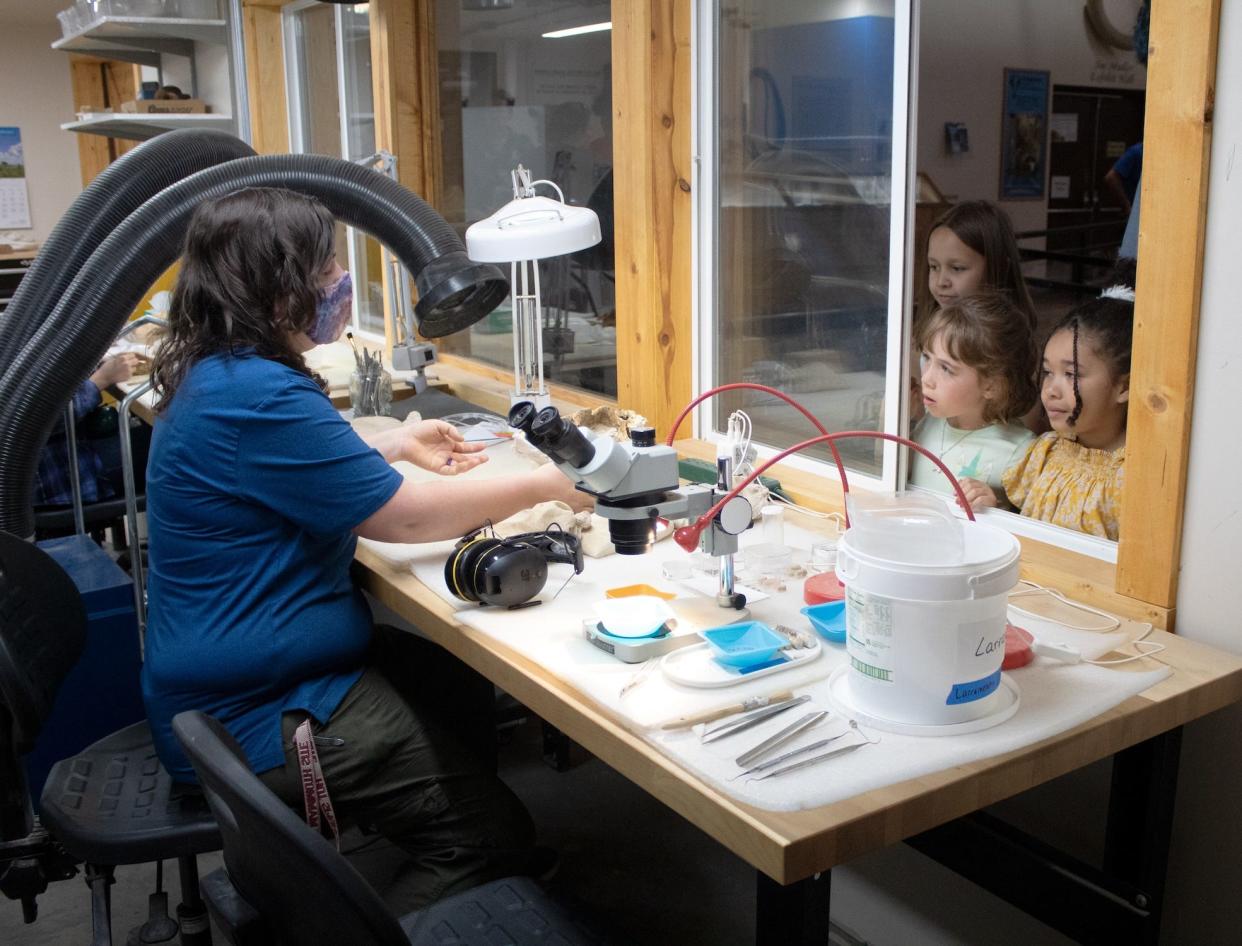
[918,0,1146,231]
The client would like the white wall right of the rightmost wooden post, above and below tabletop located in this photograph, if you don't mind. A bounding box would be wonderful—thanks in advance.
[1164,2,1242,944]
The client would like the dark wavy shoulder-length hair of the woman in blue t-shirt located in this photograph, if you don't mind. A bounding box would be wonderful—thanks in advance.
[152,187,335,408]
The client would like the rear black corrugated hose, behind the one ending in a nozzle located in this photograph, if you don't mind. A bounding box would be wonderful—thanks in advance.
[0,129,255,371]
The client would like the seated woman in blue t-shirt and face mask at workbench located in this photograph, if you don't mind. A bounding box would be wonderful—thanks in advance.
[143,189,589,905]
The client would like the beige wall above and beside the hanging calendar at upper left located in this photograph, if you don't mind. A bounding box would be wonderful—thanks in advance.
[0,17,82,241]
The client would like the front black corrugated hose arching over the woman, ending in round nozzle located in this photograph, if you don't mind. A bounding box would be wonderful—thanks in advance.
[0,145,508,538]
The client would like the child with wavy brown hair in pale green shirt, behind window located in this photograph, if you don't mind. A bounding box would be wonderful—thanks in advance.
[909,292,1038,511]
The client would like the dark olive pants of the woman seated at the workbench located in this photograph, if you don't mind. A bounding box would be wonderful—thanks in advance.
[260,627,538,906]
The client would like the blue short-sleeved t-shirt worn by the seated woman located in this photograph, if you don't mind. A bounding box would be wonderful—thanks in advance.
[143,353,401,781]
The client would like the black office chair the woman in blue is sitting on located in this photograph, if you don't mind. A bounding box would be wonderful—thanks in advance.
[0,533,220,946]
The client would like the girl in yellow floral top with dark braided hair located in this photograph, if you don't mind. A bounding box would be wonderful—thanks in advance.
[1002,269,1134,541]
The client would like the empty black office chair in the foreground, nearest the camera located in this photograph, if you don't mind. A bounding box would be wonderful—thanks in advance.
[173,711,602,946]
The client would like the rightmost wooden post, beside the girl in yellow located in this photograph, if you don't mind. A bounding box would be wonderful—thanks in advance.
[1117,0,1221,607]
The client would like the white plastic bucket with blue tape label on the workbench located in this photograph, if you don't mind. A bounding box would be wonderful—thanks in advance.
[836,523,1020,725]
